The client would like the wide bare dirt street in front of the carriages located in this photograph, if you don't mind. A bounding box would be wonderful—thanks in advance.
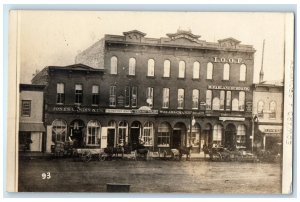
[19,159,281,194]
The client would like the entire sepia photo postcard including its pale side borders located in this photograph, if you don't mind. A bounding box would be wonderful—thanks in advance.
[7,10,294,194]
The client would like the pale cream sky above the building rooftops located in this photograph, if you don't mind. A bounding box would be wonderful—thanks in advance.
[18,11,285,83]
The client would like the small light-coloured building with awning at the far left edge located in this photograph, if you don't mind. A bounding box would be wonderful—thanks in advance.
[19,84,46,152]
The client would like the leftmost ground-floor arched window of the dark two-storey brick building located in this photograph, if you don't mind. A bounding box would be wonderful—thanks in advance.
[52,119,67,142]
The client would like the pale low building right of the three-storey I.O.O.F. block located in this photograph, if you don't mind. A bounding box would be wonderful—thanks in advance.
[253,81,284,154]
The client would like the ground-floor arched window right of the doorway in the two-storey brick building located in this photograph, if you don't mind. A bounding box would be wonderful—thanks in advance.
[86,120,101,145]
